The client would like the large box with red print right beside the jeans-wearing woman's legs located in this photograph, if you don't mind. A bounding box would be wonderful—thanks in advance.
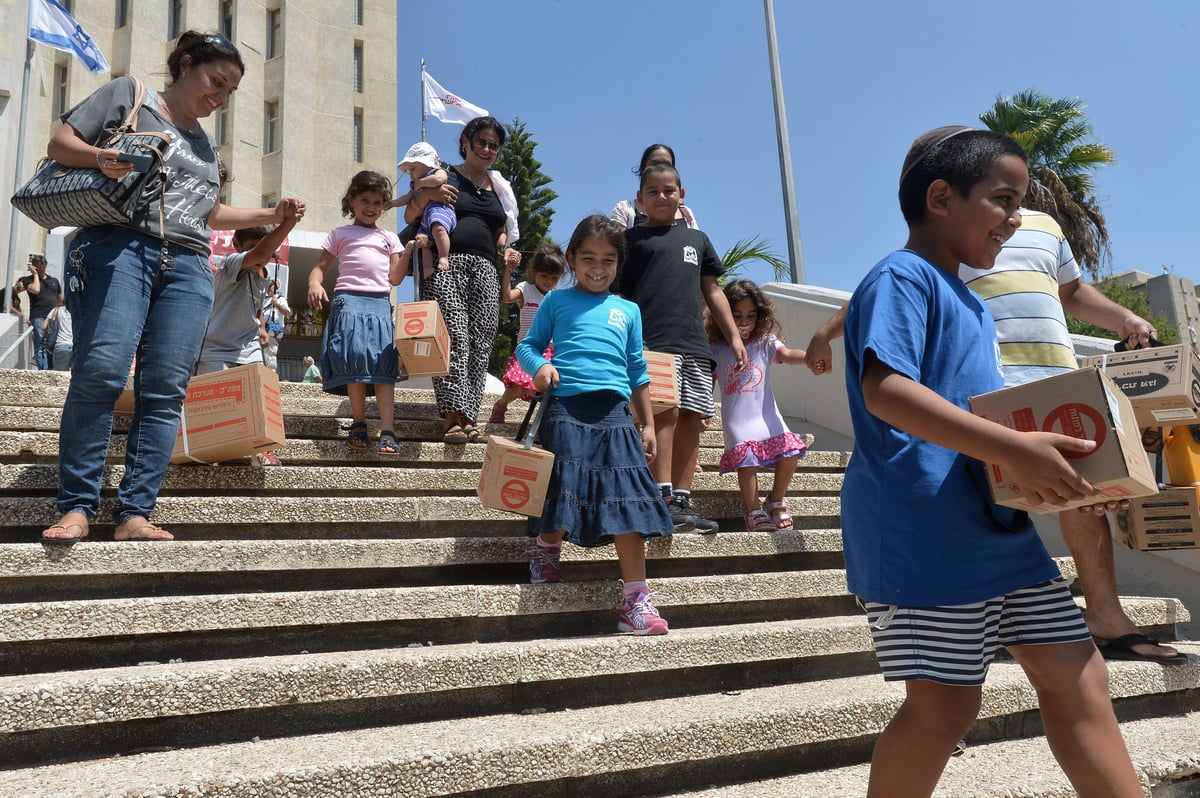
[170,364,287,463]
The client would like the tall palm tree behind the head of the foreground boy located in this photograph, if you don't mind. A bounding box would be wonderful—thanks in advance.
[979,89,1116,278]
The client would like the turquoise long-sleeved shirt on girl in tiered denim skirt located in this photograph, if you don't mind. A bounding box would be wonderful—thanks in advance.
[517,288,650,398]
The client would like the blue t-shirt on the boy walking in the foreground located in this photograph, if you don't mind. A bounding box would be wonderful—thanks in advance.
[841,250,1060,606]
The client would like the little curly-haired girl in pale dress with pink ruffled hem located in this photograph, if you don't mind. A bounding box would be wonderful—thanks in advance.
[708,280,808,532]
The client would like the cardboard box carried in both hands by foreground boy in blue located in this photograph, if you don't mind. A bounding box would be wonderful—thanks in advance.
[967,368,1158,512]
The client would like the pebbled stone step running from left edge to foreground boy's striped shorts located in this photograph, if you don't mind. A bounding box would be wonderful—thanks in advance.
[0,616,871,739]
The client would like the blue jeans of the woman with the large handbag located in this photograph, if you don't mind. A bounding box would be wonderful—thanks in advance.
[56,226,214,524]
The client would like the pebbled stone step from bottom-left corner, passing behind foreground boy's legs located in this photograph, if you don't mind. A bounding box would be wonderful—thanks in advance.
[5,640,1200,798]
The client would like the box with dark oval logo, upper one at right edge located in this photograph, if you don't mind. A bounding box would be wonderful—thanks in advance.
[1084,343,1200,427]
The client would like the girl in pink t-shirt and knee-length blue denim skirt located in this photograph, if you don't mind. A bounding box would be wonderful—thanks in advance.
[308,170,404,455]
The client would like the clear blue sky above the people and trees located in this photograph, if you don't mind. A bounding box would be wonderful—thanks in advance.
[397,0,1200,290]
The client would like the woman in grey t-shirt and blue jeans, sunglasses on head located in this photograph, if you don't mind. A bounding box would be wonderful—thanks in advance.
[42,30,304,545]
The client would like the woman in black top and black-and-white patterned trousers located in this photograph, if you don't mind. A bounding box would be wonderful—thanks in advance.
[404,116,521,443]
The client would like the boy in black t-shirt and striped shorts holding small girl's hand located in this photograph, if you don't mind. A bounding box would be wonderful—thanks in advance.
[618,162,746,533]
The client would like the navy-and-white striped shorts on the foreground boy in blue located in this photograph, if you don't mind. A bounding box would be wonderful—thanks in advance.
[863,578,1091,686]
